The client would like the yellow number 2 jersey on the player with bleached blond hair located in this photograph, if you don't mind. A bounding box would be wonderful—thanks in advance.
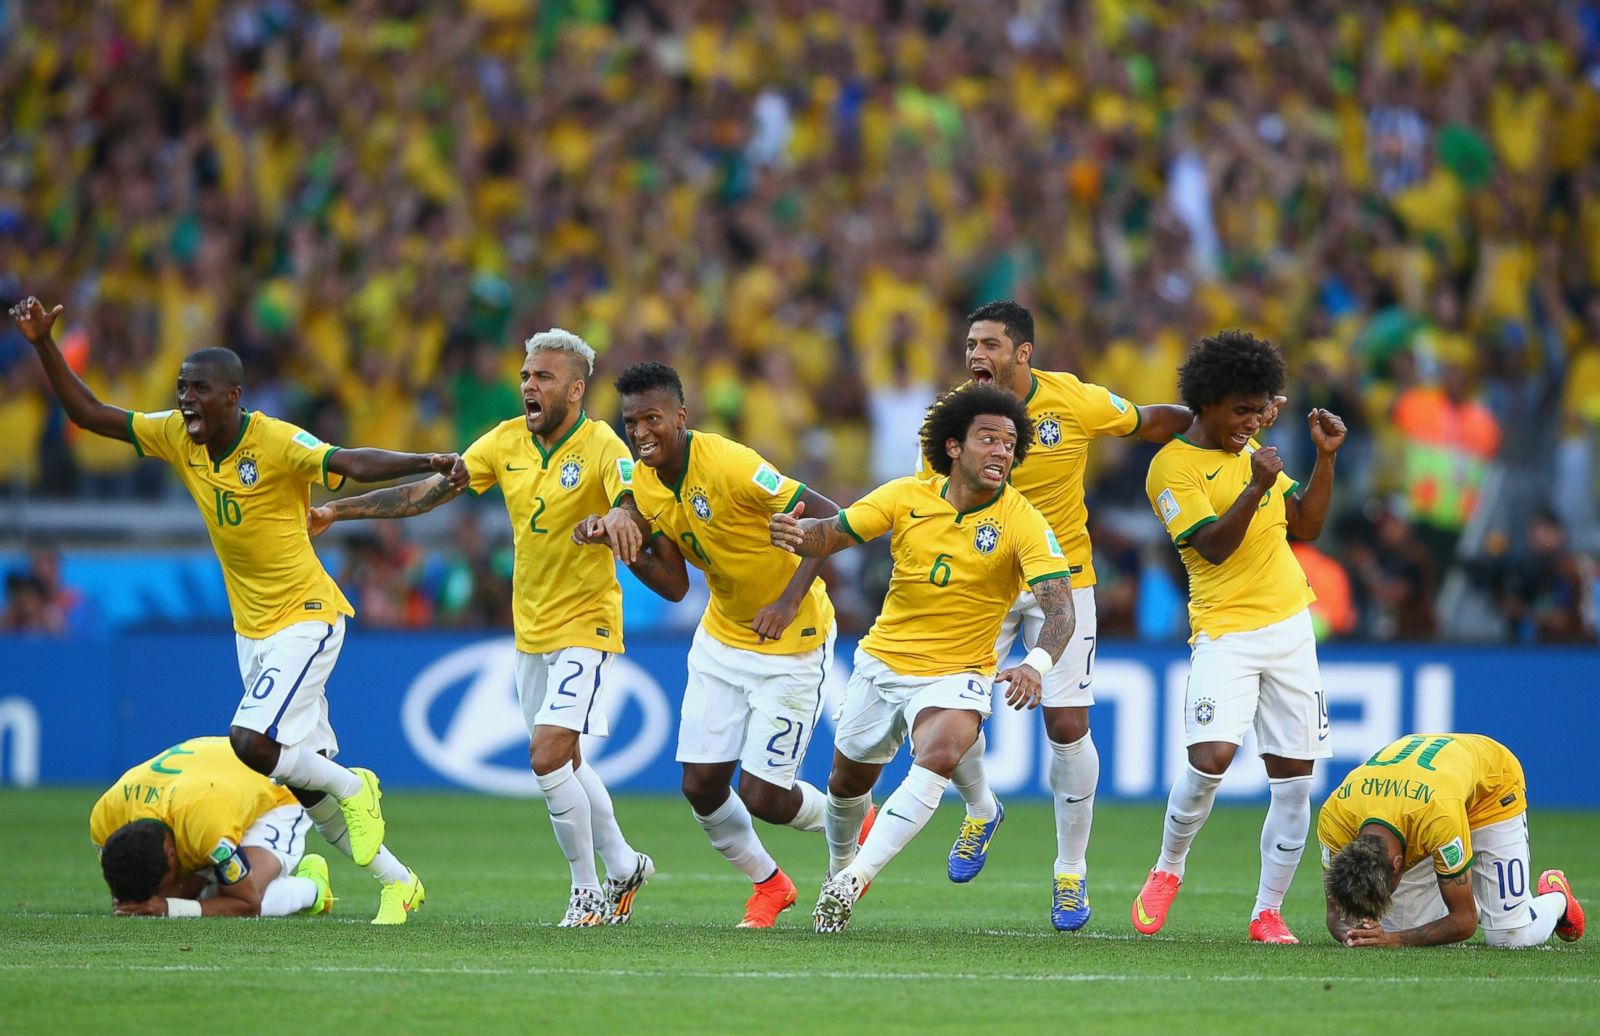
[461,412,634,654]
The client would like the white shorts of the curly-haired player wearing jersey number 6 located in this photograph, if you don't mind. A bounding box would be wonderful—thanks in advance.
[834,648,994,766]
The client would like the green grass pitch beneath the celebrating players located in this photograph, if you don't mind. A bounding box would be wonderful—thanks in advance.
[0,790,1600,1036]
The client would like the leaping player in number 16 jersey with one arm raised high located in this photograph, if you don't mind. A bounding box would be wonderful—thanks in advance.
[11,297,454,924]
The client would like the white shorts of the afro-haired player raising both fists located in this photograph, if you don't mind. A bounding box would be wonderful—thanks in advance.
[1184,611,1333,759]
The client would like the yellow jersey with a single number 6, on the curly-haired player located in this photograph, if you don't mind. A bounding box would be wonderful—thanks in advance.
[838,475,1070,676]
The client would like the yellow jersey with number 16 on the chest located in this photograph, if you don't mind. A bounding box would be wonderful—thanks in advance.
[128,411,355,640]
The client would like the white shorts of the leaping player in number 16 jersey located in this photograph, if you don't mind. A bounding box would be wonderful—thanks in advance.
[234,616,344,759]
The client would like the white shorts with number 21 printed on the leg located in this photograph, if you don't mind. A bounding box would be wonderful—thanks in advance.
[678,625,838,788]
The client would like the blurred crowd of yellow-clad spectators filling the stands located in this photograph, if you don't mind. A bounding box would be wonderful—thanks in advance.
[0,0,1600,640]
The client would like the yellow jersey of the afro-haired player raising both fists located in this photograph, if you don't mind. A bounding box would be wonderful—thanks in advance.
[1144,435,1317,640]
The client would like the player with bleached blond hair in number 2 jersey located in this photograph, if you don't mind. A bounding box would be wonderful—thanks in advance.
[310,328,656,927]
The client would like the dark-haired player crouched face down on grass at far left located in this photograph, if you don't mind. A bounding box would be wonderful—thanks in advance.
[90,737,333,918]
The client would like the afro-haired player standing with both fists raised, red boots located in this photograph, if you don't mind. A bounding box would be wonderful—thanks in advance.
[1131,331,1344,943]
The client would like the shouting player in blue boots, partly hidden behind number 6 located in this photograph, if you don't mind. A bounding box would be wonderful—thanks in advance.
[949,301,1194,932]
